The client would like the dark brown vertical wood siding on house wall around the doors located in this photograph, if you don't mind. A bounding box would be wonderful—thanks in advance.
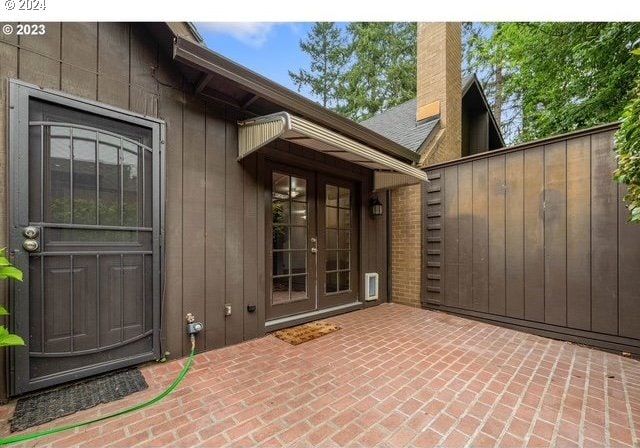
[0,23,387,396]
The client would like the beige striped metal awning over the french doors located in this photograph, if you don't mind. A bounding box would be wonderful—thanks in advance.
[238,112,428,190]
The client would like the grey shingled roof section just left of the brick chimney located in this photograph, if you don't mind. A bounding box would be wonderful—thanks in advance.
[360,98,440,152]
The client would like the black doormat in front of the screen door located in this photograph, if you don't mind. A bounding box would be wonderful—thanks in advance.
[11,369,149,432]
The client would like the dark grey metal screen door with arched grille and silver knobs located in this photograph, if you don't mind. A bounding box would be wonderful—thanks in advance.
[12,82,160,393]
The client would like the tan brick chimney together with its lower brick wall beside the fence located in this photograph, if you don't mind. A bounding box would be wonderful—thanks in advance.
[391,23,462,307]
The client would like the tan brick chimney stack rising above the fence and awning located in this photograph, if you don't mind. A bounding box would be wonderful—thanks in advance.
[416,22,462,166]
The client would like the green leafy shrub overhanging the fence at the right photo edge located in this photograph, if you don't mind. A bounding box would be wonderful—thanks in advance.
[613,48,640,223]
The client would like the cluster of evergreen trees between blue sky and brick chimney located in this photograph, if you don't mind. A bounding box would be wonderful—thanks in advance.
[289,22,416,121]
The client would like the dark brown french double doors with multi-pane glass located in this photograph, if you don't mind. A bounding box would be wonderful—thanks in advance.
[266,164,358,321]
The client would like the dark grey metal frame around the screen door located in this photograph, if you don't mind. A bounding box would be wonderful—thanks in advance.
[6,79,166,396]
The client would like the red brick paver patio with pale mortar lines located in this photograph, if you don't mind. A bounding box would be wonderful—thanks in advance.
[0,304,640,447]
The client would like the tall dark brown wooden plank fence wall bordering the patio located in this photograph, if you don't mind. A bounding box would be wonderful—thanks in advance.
[423,126,640,353]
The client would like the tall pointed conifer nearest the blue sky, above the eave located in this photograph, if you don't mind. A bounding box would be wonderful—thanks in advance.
[289,22,348,108]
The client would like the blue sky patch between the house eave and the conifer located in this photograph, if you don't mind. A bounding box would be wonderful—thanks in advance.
[196,22,313,95]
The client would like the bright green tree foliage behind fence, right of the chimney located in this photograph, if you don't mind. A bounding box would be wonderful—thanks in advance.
[464,22,640,141]
